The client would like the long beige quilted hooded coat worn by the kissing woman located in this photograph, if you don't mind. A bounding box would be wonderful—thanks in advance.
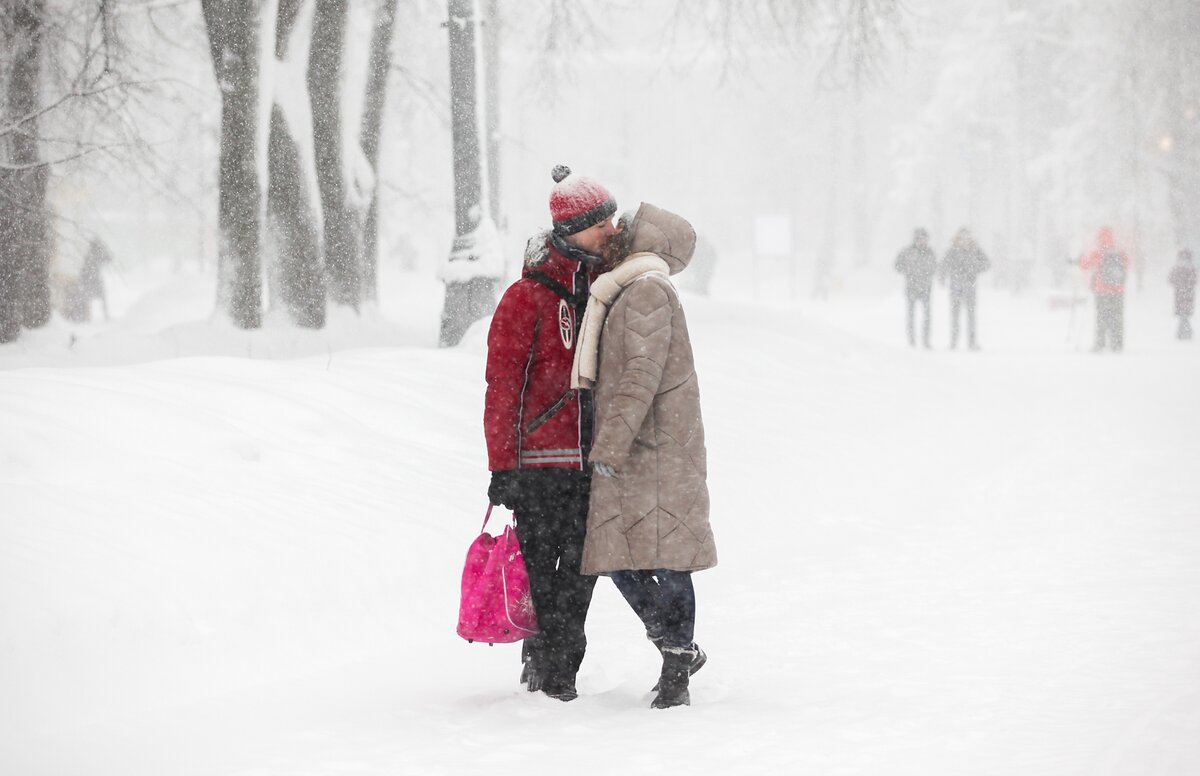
[582,204,716,575]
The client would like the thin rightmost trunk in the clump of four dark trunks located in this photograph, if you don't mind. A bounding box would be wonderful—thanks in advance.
[359,0,396,300]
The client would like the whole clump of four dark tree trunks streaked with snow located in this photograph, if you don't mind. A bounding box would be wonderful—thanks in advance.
[205,0,396,327]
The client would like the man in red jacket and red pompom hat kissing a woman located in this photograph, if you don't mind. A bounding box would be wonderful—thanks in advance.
[484,166,617,700]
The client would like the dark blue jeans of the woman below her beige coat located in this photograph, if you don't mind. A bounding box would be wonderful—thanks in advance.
[610,569,696,648]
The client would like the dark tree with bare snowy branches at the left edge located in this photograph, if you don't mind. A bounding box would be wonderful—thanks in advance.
[0,0,148,342]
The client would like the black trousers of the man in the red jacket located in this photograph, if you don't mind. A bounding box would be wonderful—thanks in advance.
[515,469,596,687]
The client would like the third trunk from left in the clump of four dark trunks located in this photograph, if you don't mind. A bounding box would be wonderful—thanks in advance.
[307,0,362,309]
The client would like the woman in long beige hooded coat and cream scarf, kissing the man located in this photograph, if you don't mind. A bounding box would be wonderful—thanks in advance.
[574,204,716,709]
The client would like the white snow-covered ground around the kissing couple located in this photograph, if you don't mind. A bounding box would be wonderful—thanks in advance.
[0,262,1200,776]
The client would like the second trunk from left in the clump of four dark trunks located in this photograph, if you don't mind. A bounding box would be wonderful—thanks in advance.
[266,0,325,329]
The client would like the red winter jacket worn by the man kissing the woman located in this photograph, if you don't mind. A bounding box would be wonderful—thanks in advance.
[484,233,594,471]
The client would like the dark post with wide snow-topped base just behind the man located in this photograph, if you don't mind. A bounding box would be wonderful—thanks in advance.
[438,0,496,347]
